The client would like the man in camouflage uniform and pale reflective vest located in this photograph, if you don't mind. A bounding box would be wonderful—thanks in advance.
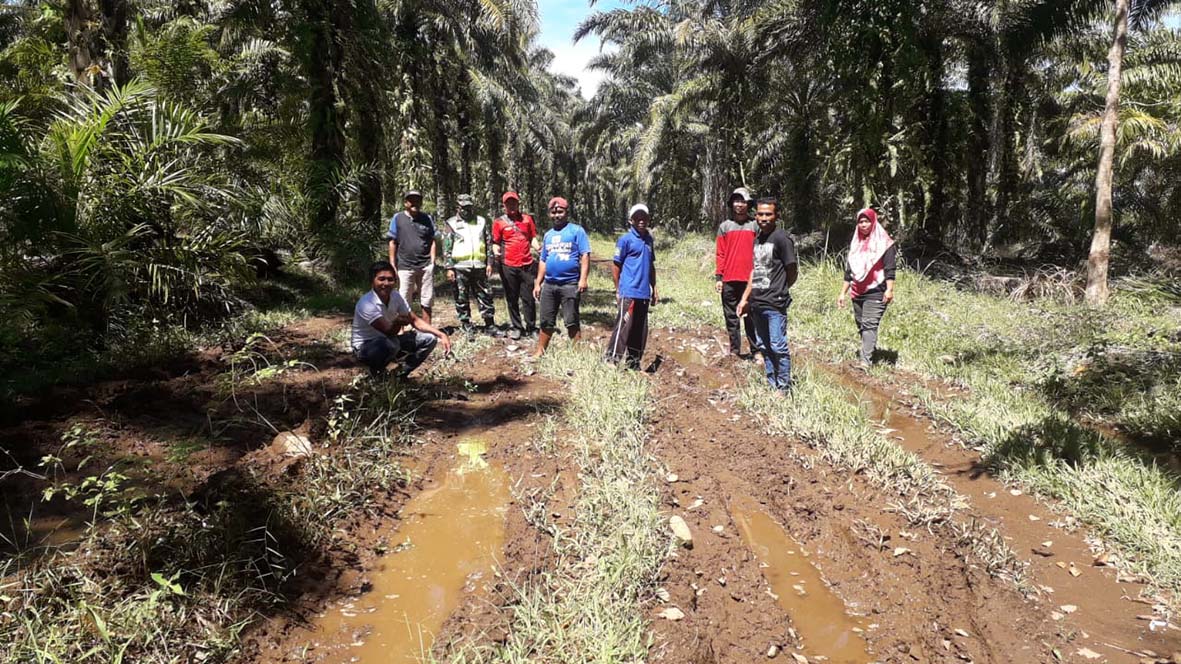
[443,194,500,337]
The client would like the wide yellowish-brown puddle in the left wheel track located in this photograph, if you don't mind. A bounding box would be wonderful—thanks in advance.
[311,440,509,664]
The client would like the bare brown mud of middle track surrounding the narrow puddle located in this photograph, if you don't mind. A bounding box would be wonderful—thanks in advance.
[650,332,1064,663]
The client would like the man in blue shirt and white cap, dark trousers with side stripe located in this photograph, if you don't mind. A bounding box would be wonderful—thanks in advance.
[607,203,658,369]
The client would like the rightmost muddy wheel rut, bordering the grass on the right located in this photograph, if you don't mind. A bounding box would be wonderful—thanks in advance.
[813,363,1181,662]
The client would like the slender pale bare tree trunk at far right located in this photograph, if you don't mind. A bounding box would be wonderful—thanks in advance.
[1087,0,1129,305]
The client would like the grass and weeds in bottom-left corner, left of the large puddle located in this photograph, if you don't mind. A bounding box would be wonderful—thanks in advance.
[0,378,413,663]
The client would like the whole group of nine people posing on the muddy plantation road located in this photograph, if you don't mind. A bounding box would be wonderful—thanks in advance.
[352,183,896,385]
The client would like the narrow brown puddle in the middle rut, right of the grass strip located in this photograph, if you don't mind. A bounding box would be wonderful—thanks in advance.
[730,497,873,664]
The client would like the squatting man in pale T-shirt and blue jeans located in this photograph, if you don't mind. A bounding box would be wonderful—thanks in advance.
[352,261,451,378]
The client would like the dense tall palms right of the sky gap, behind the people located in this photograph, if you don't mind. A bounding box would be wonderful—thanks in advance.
[580,0,1181,289]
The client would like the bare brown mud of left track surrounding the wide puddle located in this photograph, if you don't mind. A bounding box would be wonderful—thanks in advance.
[244,343,568,664]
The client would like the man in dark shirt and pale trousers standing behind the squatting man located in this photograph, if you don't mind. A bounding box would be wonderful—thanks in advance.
[385,189,435,325]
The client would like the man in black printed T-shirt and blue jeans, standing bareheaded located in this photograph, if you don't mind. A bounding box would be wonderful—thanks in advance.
[738,198,800,392]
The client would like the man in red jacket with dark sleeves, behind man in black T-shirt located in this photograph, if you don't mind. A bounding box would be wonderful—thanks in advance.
[713,187,762,357]
